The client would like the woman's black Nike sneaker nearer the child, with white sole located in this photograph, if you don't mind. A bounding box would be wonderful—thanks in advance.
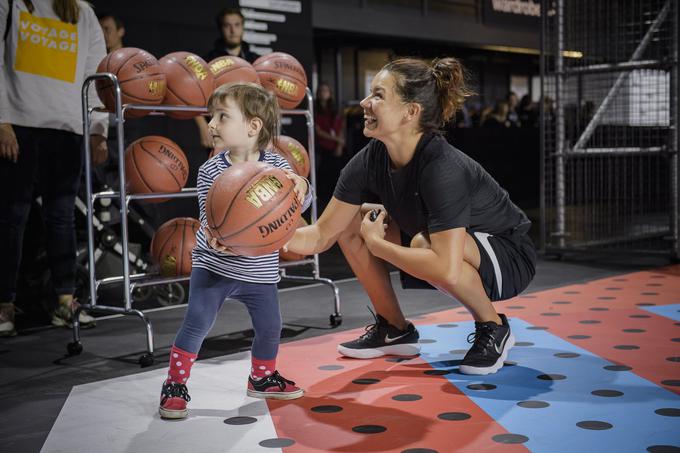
[338,315,420,359]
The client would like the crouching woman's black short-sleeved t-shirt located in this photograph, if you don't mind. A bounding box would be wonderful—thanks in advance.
[333,134,531,237]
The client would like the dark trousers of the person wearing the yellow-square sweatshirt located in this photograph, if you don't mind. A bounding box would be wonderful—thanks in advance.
[0,126,83,302]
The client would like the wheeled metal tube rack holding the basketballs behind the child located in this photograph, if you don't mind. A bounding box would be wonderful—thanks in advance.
[67,73,342,367]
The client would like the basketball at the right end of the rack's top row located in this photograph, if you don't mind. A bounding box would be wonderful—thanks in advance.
[253,52,307,109]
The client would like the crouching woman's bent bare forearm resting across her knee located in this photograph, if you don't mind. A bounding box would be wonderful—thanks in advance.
[361,212,467,285]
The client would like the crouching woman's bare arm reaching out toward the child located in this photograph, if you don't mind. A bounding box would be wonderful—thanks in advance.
[285,197,361,255]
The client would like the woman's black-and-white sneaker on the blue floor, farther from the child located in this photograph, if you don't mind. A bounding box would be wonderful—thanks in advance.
[460,313,515,375]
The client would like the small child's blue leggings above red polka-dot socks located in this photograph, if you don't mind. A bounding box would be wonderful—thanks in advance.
[175,267,281,360]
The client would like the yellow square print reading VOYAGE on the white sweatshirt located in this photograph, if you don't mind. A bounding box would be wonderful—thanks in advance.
[14,11,78,83]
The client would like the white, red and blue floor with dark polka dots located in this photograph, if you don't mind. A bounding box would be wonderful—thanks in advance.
[42,266,680,453]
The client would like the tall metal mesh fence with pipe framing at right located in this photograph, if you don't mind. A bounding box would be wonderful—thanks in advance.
[541,0,680,259]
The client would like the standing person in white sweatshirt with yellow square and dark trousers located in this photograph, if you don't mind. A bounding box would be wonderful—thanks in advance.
[0,0,108,336]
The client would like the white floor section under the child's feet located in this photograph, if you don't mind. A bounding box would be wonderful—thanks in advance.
[41,353,281,453]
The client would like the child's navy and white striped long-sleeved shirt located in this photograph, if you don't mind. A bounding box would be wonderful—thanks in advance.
[192,150,312,283]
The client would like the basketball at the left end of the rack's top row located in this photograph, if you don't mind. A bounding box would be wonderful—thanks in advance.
[95,47,165,118]
